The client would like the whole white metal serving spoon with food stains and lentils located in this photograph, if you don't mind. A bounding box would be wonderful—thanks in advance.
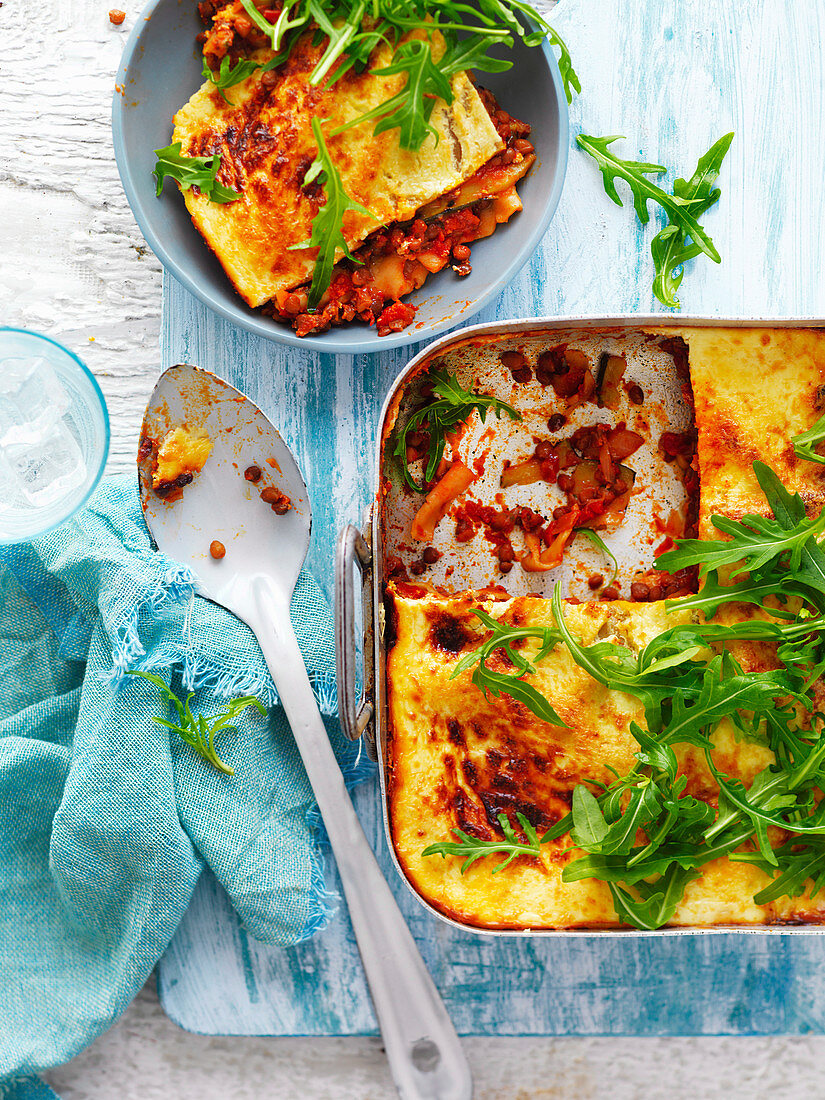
[139,364,473,1100]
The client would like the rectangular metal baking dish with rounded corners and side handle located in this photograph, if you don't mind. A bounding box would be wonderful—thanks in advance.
[336,315,825,937]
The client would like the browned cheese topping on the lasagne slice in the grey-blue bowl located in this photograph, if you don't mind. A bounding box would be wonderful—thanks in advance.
[173,35,504,306]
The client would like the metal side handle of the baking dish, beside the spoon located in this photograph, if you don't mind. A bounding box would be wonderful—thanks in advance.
[336,524,376,760]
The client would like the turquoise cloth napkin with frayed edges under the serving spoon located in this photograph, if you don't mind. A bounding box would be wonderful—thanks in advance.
[0,477,371,1082]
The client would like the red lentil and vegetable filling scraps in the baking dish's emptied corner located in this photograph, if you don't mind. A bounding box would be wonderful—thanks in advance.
[389,339,699,602]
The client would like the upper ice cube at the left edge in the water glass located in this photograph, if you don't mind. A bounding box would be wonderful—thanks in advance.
[0,359,70,446]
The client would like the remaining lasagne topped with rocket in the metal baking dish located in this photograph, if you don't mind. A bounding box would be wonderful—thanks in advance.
[385,328,825,928]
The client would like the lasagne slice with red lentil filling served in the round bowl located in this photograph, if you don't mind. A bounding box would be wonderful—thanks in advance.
[173,0,543,336]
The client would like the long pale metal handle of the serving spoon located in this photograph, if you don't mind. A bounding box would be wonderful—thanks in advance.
[250,584,473,1100]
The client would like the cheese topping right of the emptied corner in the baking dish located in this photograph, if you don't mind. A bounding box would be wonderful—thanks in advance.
[669,328,825,538]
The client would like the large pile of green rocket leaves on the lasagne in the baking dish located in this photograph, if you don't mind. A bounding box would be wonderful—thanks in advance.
[426,463,825,928]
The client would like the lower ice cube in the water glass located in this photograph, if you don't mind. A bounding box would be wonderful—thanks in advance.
[0,419,86,508]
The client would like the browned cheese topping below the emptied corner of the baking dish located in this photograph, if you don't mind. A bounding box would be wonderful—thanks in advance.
[387,592,825,928]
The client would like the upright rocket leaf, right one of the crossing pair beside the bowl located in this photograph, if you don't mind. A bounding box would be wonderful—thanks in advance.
[650,133,734,309]
